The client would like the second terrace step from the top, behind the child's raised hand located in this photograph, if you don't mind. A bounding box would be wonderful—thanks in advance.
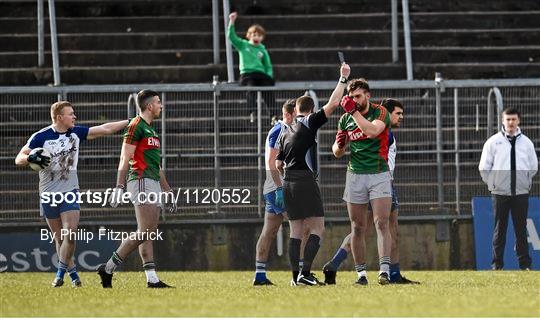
[0,11,540,34]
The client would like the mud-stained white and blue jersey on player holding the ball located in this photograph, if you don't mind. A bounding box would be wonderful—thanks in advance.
[25,125,89,193]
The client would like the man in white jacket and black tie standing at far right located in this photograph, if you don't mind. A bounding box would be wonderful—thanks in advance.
[478,108,538,270]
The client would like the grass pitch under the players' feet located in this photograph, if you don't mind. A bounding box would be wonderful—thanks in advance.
[0,271,540,317]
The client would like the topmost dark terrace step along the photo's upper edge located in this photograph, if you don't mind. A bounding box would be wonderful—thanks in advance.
[4,0,540,17]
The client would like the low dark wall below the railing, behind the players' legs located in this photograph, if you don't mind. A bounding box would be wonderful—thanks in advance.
[2,219,475,271]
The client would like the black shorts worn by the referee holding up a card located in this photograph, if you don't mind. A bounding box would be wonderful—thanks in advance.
[283,179,324,220]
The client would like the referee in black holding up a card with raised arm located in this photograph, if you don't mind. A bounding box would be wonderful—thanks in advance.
[276,63,351,286]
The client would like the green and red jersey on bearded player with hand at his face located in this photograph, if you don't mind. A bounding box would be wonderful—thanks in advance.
[338,102,390,174]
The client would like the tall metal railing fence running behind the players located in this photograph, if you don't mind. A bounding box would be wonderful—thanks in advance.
[0,78,540,224]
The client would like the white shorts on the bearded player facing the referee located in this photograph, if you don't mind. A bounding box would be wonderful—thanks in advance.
[343,171,392,204]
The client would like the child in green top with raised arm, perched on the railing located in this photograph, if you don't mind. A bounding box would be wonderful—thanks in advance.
[227,12,276,122]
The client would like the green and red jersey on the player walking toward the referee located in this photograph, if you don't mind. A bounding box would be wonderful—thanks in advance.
[124,116,161,181]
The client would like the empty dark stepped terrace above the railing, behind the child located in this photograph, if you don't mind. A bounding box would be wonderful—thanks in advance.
[0,0,540,85]
